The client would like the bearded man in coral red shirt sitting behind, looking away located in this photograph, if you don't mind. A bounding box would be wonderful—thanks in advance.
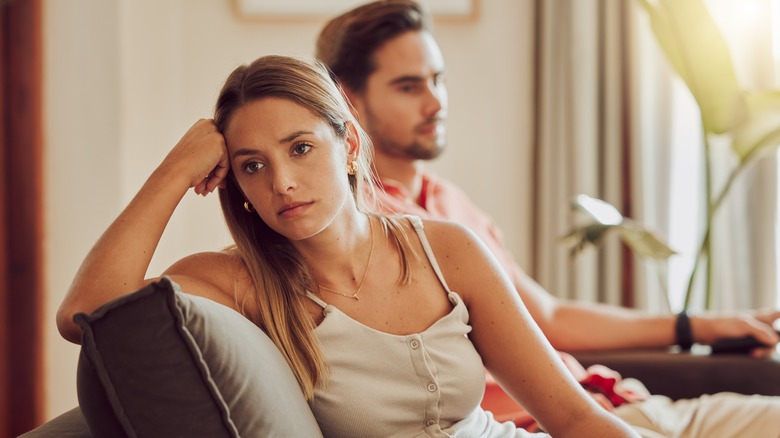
[317,0,780,436]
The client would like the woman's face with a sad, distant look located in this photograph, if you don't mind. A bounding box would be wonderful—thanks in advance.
[224,97,356,241]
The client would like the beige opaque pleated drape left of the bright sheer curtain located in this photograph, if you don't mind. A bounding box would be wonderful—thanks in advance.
[531,0,655,307]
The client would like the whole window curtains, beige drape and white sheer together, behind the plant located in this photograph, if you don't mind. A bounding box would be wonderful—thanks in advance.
[531,0,780,312]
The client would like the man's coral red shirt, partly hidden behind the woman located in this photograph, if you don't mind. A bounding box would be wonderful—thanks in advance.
[379,174,649,431]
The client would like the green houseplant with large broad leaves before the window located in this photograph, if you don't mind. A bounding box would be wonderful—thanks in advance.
[568,0,780,309]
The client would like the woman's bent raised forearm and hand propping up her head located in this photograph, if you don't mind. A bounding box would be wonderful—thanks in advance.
[57,120,229,343]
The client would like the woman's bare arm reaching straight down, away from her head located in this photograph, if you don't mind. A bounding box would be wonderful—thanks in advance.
[425,221,638,437]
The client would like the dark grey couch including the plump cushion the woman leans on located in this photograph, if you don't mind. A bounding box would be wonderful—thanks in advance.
[22,278,780,438]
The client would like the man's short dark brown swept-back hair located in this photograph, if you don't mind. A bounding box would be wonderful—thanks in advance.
[316,0,431,93]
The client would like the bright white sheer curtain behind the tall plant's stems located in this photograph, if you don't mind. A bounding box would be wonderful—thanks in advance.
[636,0,778,311]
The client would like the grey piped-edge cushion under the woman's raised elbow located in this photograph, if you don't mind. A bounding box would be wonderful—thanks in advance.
[75,278,321,437]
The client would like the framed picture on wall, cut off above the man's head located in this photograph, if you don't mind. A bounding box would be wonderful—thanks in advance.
[232,0,479,21]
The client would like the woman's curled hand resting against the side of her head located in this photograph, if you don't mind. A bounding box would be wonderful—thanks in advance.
[161,119,230,196]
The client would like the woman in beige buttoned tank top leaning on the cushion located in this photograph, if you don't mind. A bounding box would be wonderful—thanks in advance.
[58,56,633,437]
